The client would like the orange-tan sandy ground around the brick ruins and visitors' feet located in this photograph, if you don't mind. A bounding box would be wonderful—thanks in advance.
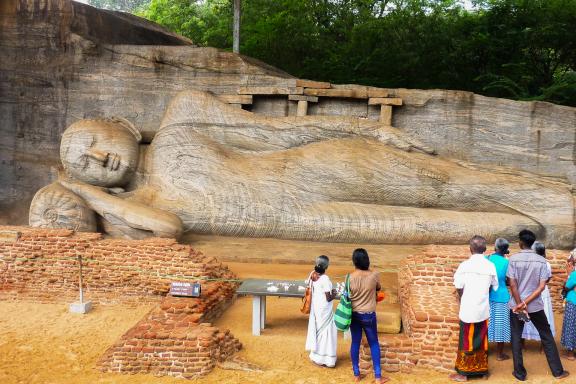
[0,238,576,384]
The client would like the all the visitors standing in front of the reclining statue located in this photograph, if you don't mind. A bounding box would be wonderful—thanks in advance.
[306,230,576,383]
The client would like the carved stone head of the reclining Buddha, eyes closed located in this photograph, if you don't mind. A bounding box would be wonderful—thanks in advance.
[60,120,139,187]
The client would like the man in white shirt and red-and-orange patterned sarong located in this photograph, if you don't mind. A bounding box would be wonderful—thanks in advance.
[449,236,498,381]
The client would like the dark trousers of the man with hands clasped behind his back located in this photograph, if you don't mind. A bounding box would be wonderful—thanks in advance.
[510,310,564,380]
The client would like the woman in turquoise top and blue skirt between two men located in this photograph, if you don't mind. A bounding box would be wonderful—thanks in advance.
[488,238,510,361]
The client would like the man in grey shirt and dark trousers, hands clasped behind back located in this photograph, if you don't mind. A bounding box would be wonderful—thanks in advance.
[506,229,569,381]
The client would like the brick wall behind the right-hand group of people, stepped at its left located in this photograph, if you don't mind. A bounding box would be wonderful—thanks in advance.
[361,245,568,372]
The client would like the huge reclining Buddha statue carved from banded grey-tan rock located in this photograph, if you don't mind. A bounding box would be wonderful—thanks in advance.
[30,91,574,247]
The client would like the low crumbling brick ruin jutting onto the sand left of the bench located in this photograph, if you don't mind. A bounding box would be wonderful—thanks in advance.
[98,292,242,379]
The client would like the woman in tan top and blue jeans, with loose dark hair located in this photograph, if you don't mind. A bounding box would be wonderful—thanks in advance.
[350,248,389,383]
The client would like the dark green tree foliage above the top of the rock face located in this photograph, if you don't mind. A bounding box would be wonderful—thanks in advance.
[136,0,576,106]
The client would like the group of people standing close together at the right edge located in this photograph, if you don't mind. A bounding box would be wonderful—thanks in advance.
[450,230,576,381]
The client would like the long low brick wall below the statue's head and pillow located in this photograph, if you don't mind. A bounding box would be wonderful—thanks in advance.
[0,226,236,303]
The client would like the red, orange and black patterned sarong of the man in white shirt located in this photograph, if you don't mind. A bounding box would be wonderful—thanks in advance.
[456,320,488,376]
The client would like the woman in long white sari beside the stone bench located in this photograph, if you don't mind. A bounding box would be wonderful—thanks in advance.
[306,256,338,367]
